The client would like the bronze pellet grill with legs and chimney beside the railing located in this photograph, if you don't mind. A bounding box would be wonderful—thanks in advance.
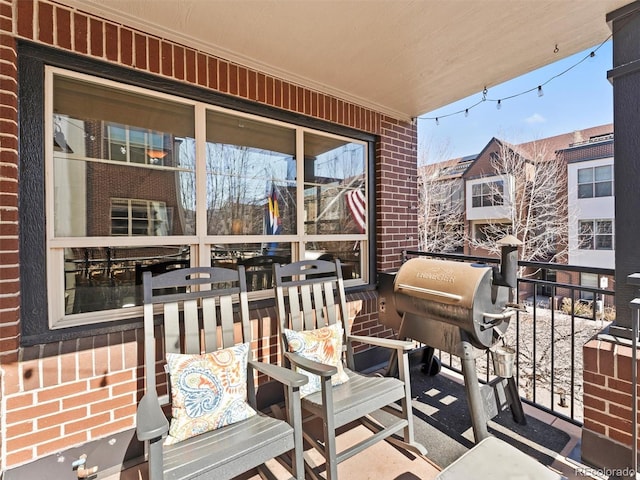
[378,236,526,443]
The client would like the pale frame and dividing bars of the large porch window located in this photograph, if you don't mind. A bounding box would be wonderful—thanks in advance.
[44,66,373,329]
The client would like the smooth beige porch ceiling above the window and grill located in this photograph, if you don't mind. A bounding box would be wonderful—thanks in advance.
[61,0,631,119]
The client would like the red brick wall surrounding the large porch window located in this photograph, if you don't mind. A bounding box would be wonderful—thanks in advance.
[0,0,417,471]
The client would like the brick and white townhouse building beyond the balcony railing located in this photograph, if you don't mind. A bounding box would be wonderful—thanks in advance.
[419,124,615,300]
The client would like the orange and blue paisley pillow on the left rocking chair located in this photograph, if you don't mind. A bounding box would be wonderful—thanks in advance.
[164,343,256,445]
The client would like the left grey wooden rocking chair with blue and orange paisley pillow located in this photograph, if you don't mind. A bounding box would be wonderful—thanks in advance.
[137,266,307,480]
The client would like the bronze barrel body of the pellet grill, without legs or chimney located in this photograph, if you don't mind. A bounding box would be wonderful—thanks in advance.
[380,258,513,353]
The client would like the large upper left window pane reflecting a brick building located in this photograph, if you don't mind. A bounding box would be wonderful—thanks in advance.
[52,76,195,237]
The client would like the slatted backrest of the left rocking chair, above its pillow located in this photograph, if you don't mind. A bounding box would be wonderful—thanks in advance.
[143,266,251,398]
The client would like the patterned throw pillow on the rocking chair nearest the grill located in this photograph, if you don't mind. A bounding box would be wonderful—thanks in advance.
[284,323,349,397]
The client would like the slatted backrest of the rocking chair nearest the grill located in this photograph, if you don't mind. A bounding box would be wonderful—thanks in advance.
[274,260,349,356]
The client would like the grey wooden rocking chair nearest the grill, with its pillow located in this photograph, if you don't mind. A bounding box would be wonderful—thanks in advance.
[274,260,426,480]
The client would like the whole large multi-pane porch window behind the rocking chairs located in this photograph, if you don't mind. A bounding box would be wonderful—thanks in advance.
[45,67,369,328]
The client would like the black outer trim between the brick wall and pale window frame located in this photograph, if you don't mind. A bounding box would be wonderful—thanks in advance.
[18,41,376,345]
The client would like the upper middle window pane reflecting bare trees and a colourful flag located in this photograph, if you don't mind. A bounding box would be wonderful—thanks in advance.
[206,111,296,235]
